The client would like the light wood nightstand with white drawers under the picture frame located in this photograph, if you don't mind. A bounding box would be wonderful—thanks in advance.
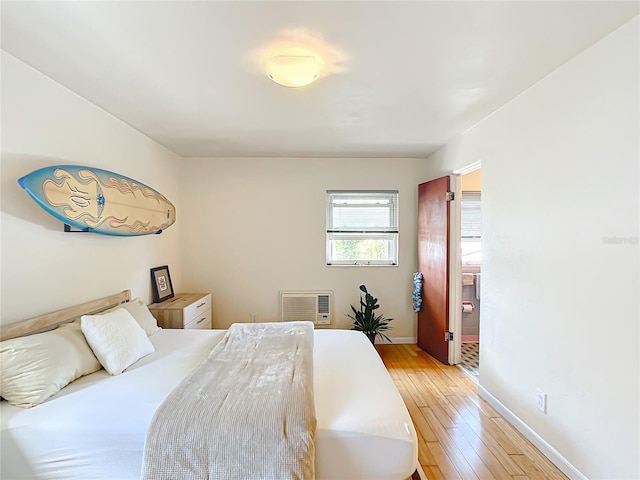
[149,293,211,329]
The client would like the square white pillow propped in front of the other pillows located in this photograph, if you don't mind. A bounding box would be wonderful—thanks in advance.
[80,308,154,375]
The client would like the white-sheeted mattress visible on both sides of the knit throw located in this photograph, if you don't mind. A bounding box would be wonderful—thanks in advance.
[0,330,418,480]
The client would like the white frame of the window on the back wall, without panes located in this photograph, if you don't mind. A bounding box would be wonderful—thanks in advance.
[325,190,400,267]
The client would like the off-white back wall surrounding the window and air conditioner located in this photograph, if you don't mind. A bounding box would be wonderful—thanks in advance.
[183,158,424,337]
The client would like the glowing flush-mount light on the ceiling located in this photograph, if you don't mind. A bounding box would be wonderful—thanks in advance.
[265,48,323,88]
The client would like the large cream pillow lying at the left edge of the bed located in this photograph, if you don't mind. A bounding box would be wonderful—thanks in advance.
[0,321,101,407]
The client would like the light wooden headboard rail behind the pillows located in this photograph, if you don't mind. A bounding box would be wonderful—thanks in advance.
[0,290,131,341]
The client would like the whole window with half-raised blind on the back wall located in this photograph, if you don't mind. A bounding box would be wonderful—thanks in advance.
[327,190,398,265]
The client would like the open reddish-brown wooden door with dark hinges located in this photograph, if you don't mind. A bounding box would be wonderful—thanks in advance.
[418,177,450,365]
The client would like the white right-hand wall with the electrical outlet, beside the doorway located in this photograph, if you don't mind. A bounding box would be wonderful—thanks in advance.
[421,18,640,480]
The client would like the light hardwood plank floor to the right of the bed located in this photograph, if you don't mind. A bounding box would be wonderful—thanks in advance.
[376,344,567,480]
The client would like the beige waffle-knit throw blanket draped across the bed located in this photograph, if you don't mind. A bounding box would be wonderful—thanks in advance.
[142,322,316,480]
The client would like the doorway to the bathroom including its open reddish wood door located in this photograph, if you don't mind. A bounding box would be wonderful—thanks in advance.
[417,169,481,368]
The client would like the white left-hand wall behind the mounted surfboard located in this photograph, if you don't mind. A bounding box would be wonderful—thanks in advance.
[0,52,183,324]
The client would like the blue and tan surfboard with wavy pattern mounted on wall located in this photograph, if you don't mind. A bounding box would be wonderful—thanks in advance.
[18,165,176,237]
